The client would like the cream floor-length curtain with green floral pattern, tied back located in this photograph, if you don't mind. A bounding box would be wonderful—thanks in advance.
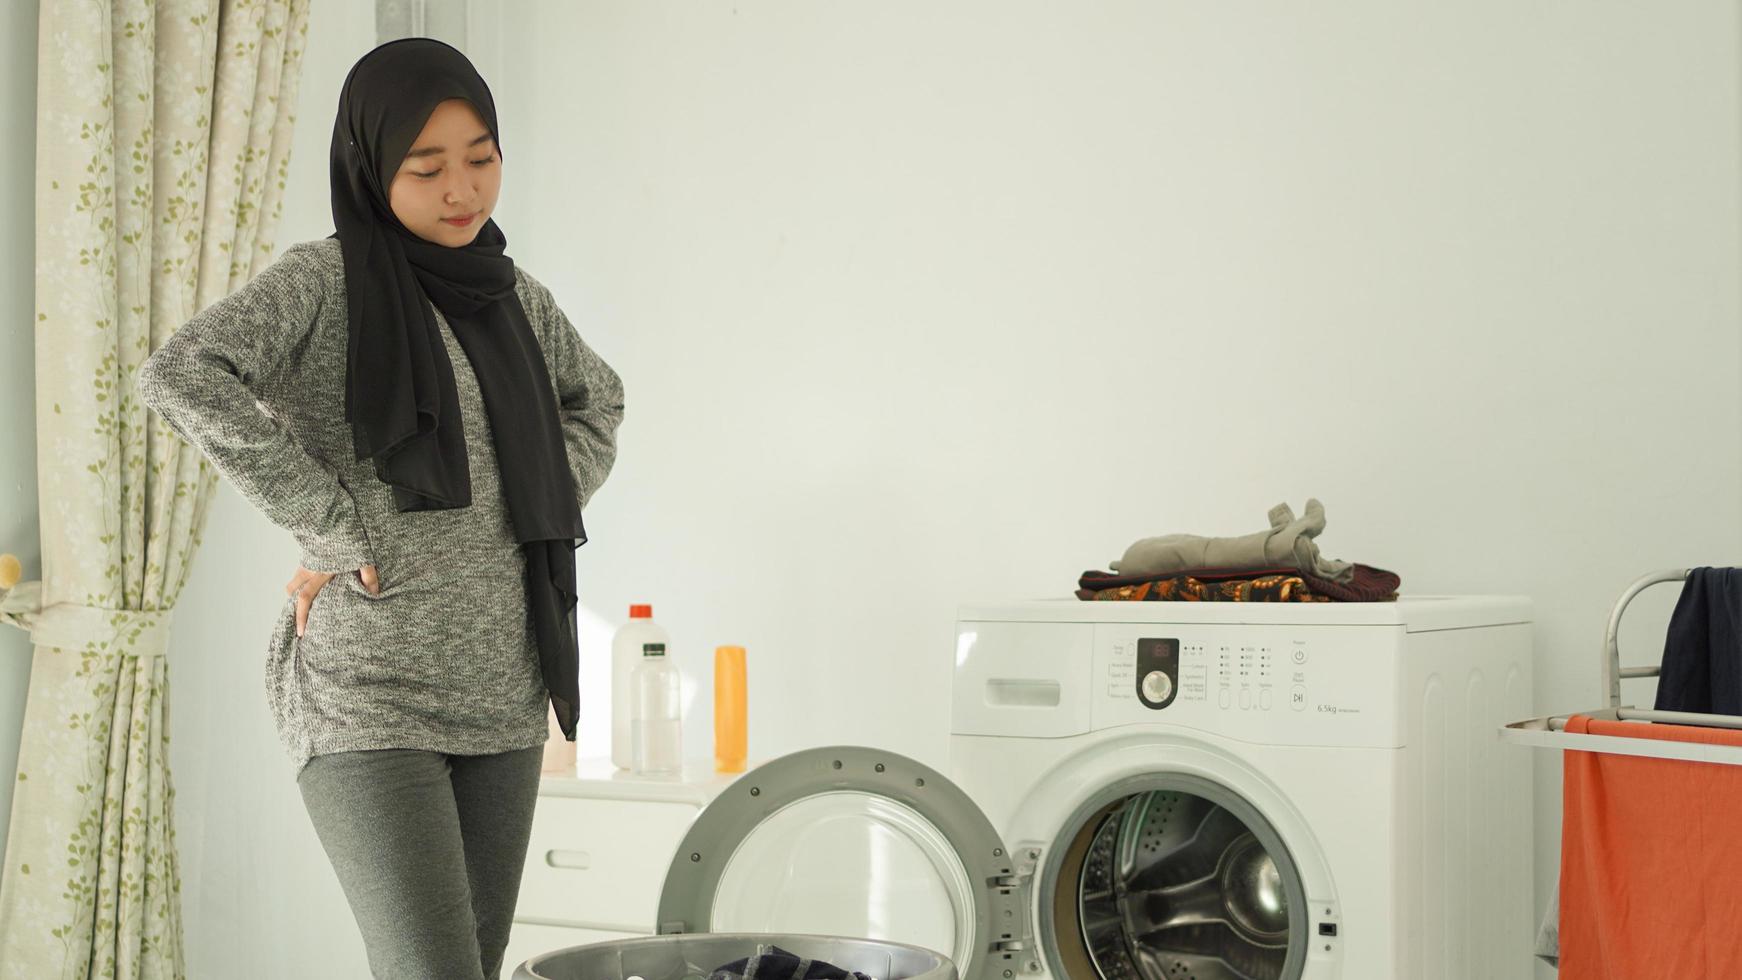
[0,0,308,980]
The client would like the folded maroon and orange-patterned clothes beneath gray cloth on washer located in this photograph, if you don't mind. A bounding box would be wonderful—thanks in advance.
[1077,564,1402,602]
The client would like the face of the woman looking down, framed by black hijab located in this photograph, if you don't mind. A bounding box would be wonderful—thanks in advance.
[387,99,502,249]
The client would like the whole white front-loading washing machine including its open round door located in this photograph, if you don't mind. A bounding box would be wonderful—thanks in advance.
[550,595,1533,980]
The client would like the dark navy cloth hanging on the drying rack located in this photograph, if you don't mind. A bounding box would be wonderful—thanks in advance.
[1657,567,1742,715]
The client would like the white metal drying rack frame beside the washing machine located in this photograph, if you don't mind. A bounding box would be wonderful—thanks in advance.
[1500,567,1742,766]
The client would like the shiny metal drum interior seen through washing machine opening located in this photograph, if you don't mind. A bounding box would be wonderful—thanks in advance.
[1073,790,1303,980]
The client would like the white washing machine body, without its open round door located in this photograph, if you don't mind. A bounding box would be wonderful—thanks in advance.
[949,595,1535,980]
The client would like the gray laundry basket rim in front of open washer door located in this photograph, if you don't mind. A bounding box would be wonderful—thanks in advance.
[514,933,956,980]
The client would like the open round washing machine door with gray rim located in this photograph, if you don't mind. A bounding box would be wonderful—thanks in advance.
[658,747,1033,980]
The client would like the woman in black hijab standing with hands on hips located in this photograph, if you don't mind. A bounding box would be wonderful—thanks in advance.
[138,38,624,980]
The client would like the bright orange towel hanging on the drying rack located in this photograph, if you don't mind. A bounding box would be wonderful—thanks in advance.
[1559,715,1742,980]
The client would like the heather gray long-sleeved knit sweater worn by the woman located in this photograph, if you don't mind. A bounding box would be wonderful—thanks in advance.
[138,238,624,775]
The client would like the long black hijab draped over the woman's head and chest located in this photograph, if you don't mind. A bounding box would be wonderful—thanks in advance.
[329,37,587,742]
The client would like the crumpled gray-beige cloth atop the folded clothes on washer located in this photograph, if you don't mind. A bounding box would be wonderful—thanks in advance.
[1110,498,1355,583]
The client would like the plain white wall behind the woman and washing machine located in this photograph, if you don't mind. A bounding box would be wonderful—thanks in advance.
[0,0,1742,977]
